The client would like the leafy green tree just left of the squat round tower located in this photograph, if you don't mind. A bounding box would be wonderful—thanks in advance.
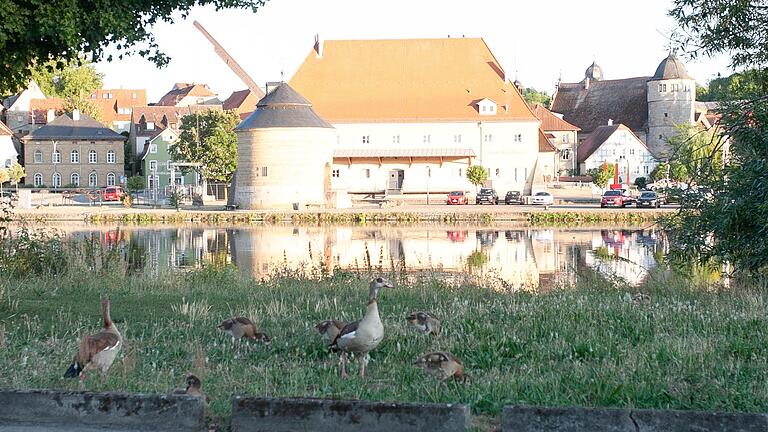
[168,111,240,183]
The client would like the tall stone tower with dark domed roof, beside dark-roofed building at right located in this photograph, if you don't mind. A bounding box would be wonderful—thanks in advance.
[646,54,696,159]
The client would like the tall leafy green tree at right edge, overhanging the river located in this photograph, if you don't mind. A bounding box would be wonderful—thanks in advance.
[665,0,768,275]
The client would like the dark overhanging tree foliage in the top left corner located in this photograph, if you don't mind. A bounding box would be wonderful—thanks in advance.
[0,0,266,94]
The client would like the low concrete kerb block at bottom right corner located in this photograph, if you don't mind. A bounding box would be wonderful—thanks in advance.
[501,407,768,432]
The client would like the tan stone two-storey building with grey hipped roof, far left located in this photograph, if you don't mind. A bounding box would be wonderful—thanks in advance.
[22,110,125,188]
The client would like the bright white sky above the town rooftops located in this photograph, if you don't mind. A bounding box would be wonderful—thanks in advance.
[96,0,731,102]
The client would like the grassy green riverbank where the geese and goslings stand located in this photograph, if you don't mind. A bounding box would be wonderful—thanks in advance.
[0,243,768,423]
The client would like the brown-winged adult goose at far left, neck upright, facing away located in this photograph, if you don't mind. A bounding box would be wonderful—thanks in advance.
[64,297,123,386]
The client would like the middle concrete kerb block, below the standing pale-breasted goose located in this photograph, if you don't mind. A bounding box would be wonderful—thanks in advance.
[232,397,469,432]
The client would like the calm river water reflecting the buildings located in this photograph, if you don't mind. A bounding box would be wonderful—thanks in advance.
[54,225,666,289]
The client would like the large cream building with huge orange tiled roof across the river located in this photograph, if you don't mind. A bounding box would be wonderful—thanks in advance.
[289,38,543,193]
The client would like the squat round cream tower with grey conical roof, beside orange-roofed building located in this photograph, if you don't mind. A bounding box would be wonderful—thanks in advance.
[234,82,336,209]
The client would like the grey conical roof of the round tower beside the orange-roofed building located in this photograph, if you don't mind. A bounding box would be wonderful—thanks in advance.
[235,82,333,130]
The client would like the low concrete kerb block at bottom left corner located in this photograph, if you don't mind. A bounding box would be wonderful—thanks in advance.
[0,390,207,432]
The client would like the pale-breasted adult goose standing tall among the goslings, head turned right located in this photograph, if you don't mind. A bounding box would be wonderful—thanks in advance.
[330,277,394,379]
